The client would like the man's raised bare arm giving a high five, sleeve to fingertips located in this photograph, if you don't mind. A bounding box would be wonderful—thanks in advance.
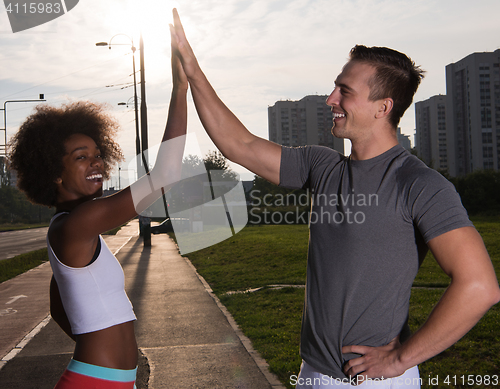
[170,9,281,184]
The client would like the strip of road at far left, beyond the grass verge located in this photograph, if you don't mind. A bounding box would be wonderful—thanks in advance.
[0,227,48,260]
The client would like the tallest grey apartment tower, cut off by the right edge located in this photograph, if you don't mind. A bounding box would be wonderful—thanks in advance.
[446,49,500,176]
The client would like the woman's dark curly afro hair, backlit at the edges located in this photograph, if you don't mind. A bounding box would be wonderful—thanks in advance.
[9,101,123,207]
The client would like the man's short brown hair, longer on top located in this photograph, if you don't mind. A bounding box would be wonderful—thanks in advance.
[349,45,425,128]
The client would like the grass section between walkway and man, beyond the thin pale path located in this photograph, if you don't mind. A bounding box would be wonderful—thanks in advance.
[188,225,308,295]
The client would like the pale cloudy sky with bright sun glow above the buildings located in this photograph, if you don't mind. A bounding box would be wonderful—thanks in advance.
[0,0,500,187]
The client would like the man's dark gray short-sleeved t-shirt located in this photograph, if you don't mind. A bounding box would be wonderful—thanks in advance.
[280,145,472,378]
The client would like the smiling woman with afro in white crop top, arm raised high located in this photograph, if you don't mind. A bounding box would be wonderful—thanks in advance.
[10,31,188,389]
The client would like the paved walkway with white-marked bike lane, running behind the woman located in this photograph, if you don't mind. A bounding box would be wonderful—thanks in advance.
[0,221,284,389]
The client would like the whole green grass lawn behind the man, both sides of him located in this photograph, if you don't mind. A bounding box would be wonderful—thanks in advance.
[187,218,500,388]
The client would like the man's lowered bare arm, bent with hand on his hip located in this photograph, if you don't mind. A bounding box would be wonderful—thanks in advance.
[342,227,500,378]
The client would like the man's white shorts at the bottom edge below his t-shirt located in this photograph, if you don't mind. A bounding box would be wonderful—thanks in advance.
[290,361,421,389]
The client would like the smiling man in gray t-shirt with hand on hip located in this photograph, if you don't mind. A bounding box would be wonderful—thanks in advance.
[172,11,500,388]
